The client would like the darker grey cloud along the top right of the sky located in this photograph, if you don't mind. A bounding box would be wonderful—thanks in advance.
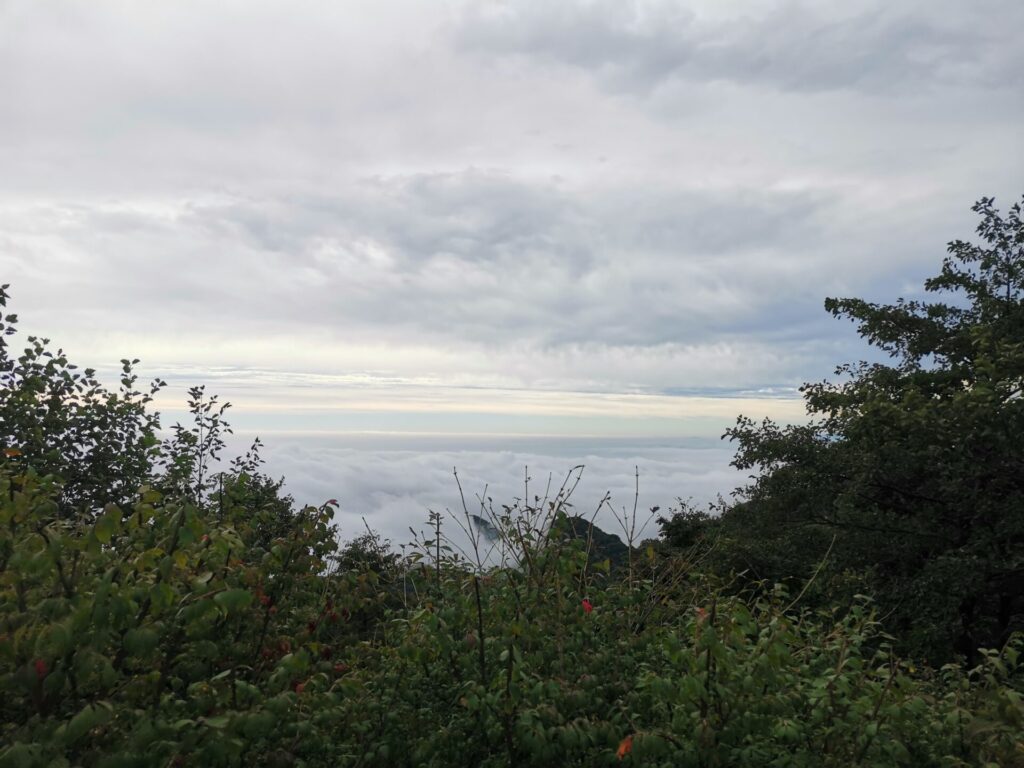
[457,0,1024,99]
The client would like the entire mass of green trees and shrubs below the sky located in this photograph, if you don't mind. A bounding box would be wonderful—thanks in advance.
[0,201,1024,766]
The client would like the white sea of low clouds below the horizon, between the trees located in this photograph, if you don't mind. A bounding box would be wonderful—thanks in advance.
[249,438,743,545]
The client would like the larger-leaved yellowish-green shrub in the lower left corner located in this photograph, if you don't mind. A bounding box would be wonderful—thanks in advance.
[0,467,344,765]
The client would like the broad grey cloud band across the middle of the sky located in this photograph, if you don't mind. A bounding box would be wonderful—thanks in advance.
[2,171,897,354]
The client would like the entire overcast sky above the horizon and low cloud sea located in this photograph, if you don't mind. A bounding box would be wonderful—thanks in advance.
[0,0,1024,540]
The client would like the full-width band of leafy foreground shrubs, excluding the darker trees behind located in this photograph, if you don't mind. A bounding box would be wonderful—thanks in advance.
[0,457,1024,766]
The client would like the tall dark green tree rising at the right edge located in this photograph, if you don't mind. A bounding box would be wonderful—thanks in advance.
[688,198,1024,657]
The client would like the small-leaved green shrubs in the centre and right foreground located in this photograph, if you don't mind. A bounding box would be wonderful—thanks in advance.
[337,499,1024,766]
